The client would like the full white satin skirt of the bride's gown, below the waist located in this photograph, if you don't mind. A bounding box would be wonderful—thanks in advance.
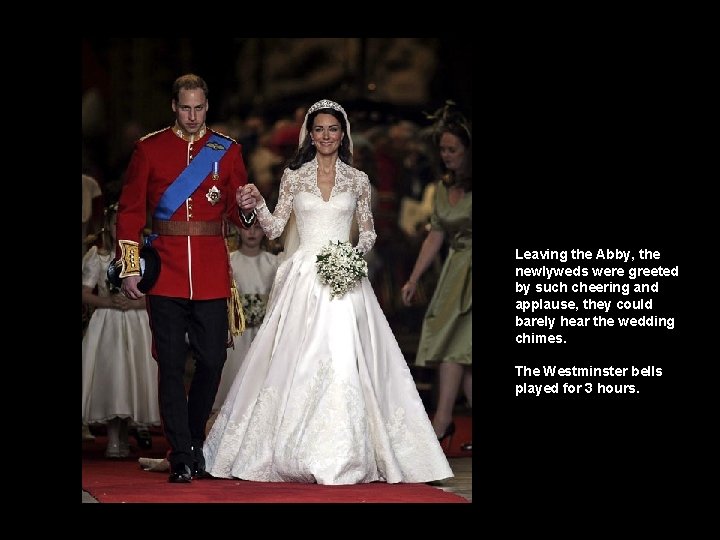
[204,250,453,484]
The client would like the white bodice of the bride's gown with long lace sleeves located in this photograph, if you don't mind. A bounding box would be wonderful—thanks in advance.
[257,159,377,253]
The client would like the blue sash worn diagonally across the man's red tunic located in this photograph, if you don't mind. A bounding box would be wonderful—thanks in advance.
[153,134,231,219]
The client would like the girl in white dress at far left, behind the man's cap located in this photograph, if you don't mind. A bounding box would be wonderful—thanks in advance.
[82,205,160,458]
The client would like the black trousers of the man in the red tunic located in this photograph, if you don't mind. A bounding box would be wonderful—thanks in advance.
[147,295,228,470]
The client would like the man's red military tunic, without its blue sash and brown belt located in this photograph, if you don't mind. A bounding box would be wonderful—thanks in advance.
[117,128,247,300]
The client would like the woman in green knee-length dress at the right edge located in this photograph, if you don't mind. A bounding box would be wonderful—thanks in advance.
[401,107,472,450]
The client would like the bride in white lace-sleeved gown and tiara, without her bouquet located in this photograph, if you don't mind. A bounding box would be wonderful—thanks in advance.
[203,100,453,484]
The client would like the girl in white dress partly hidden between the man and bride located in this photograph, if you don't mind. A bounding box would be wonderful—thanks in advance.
[213,222,278,411]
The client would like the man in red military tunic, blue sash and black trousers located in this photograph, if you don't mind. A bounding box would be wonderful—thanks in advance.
[116,74,262,483]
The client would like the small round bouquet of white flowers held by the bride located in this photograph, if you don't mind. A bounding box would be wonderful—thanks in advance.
[316,240,367,298]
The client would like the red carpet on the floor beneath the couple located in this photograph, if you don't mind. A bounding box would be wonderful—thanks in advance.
[82,436,468,503]
